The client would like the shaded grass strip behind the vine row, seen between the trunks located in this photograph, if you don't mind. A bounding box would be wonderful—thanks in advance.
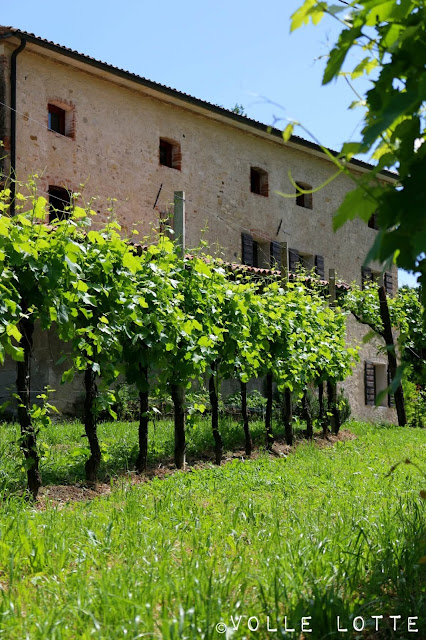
[0,417,290,491]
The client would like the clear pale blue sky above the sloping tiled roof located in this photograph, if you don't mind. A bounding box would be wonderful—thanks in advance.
[1,0,418,281]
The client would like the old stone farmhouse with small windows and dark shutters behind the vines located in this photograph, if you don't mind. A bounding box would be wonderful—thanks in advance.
[0,27,397,420]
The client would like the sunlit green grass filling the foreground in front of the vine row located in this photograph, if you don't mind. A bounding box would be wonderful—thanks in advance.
[0,423,426,640]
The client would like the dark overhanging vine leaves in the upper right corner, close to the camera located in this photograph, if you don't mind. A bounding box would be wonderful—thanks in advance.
[292,0,426,322]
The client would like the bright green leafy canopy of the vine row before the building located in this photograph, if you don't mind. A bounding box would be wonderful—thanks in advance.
[0,185,362,490]
